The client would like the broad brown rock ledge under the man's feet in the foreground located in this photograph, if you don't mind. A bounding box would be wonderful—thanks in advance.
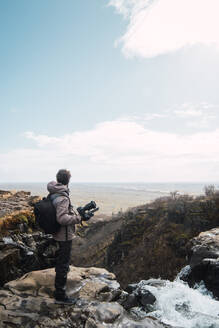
[0,267,169,328]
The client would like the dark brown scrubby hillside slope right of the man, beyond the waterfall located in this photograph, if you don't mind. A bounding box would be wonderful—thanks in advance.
[72,192,219,288]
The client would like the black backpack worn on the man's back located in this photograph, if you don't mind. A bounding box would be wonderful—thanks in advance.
[34,195,61,234]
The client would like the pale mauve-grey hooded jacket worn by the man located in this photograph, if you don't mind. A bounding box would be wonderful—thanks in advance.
[47,181,81,241]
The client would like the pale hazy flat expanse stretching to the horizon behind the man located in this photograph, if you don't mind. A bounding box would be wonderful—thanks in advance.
[0,183,219,216]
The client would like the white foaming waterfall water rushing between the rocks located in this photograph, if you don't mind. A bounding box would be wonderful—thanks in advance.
[131,266,219,328]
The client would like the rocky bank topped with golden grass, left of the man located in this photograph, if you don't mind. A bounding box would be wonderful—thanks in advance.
[0,190,56,286]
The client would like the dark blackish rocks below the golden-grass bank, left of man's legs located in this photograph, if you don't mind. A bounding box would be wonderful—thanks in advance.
[0,231,57,286]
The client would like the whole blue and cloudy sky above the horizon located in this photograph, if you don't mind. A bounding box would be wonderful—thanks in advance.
[0,0,219,182]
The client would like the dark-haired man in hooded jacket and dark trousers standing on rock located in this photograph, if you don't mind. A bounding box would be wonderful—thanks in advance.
[47,169,81,305]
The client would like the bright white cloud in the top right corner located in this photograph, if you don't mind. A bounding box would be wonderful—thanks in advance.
[109,0,219,58]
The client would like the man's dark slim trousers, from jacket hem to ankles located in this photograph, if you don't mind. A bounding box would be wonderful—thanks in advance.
[54,240,72,299]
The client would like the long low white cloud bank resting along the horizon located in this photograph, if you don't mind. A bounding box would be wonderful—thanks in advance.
[0,120,219,182]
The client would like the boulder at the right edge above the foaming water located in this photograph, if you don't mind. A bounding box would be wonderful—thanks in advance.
[184,228,219,299]
